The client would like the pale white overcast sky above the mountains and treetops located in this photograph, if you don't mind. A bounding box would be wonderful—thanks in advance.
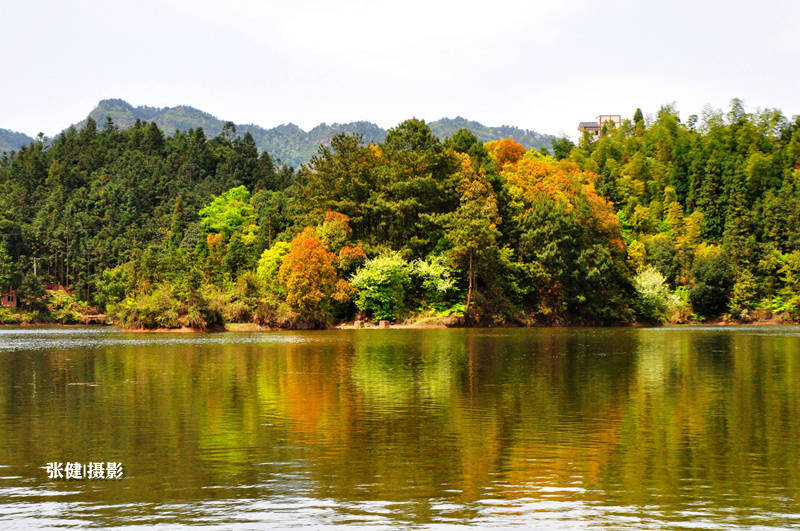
[0,0,800,136]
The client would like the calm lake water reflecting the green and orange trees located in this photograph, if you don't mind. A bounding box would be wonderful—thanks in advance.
[0,327,800,529]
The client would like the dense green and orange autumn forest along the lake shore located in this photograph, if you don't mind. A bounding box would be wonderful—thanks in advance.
[0,100,800,328]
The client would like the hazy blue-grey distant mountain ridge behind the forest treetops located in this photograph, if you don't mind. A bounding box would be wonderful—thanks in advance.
[0,99,555,167]
